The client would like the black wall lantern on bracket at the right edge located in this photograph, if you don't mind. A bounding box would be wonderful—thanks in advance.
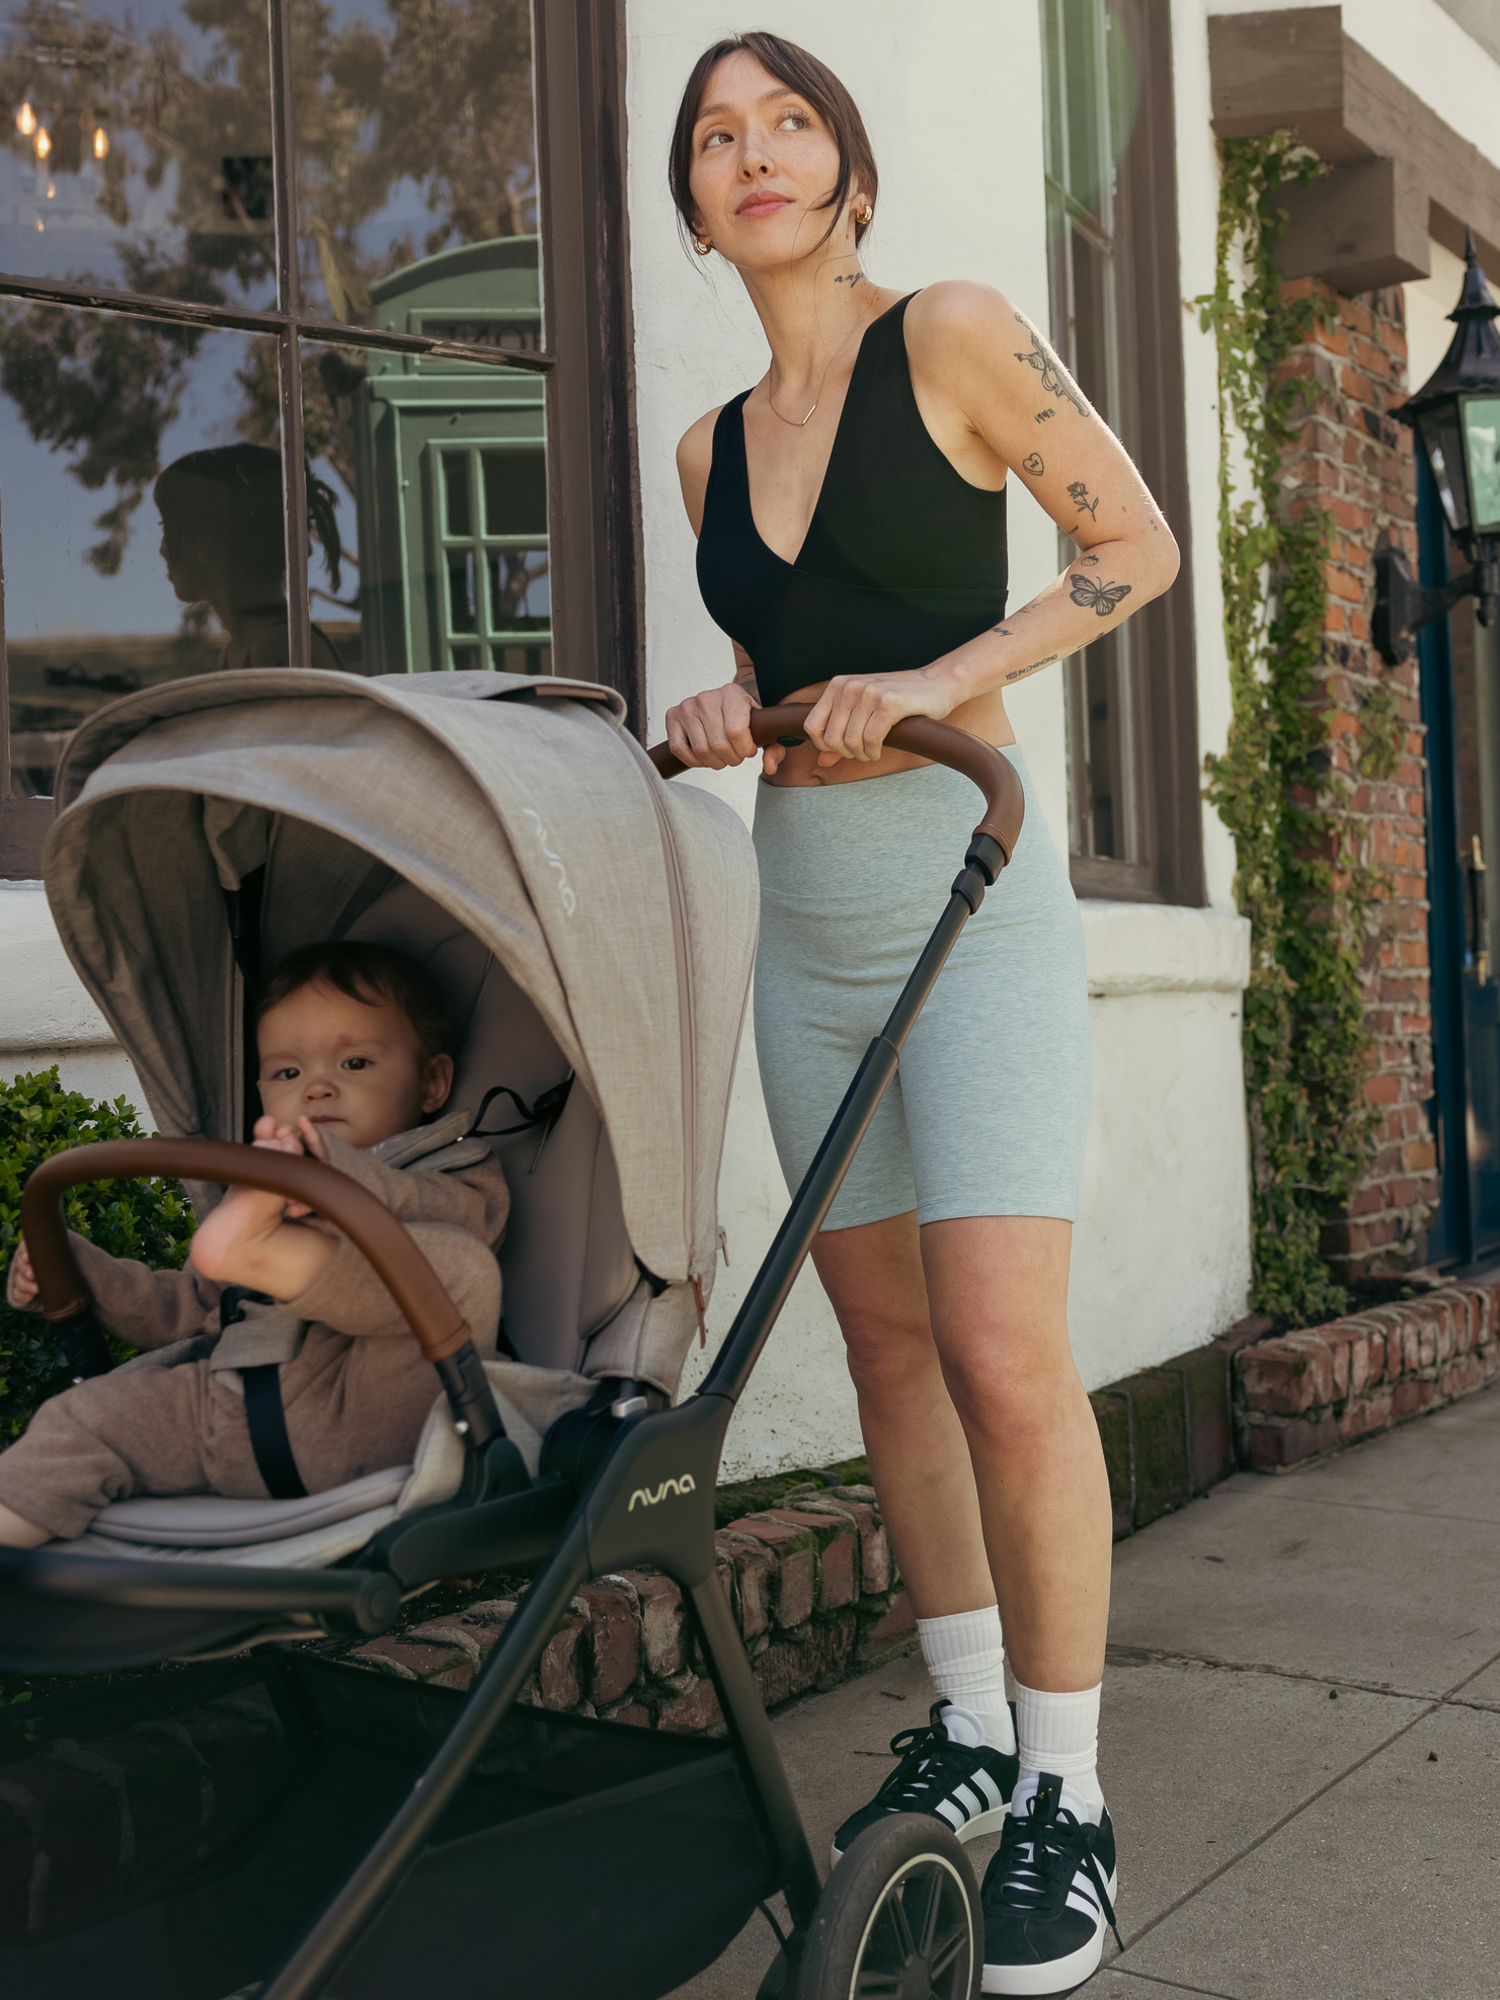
[1372,230,1500,666]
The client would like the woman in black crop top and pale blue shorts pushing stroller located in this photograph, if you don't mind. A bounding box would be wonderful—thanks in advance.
[668,34,1178,1994]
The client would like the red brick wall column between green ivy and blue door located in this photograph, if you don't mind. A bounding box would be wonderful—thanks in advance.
[1286,278,1438,1278]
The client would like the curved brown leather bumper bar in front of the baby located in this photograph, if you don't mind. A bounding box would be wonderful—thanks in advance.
[20,1138,470,1362]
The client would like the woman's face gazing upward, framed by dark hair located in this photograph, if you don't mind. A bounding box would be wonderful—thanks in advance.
[688,50,864,270]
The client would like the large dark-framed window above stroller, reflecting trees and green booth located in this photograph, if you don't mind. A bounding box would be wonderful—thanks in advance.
[0,0,640,876]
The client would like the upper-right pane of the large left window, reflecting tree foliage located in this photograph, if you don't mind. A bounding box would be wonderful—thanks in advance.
[292,0,540,332]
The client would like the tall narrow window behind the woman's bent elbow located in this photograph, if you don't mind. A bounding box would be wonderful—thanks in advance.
[1042,0,1204,904]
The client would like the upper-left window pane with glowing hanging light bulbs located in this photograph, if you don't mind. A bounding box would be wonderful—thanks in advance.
[0,0,276,306]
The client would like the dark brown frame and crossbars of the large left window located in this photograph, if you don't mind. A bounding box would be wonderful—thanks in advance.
[0,0,644,882]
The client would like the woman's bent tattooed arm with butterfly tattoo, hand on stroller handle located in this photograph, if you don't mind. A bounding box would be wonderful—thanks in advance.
[808,282,1178,764]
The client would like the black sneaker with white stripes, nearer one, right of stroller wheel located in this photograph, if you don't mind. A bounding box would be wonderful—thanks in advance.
[980,1772,1124,1994]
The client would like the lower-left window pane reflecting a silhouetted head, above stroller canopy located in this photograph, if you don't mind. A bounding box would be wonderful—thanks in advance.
[0,300,290,796]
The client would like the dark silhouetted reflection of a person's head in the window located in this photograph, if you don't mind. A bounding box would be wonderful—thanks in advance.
[156,444,344,670]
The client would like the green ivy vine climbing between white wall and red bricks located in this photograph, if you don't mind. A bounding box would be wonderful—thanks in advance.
[1194,132,1402,1326]
